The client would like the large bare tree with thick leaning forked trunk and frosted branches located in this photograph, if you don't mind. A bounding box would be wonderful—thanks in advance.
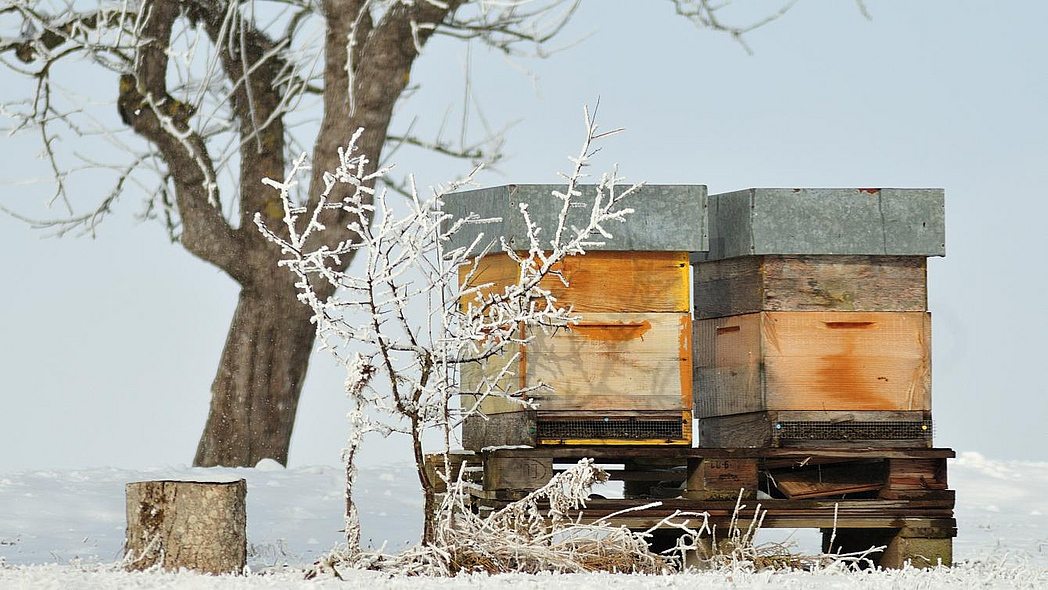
[0,0,825,465]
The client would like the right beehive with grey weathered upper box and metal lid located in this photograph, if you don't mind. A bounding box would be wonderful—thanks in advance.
[692,189,945,446]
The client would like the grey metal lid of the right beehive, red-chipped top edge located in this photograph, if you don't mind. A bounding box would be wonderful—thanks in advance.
[693,189,946,262]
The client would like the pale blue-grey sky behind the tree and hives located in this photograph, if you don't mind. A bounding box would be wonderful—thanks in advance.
[0,0,1048,471]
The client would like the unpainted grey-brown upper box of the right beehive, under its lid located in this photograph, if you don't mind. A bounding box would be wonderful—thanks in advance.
[695,255,927,319]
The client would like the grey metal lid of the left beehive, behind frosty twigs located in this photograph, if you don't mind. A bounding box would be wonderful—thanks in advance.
[444,184,708,252]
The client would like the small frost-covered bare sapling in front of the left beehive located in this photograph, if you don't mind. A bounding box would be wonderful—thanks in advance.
[255,104,639,547]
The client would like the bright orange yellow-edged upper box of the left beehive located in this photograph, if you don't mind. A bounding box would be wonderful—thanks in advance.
[459,252,691,312]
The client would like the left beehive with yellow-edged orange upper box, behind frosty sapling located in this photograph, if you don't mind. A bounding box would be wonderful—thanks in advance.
[445,184,707,450]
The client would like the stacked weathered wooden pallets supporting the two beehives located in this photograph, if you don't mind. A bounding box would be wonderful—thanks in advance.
[446,445,957,567]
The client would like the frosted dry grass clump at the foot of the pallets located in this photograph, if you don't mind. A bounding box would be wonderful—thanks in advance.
[309,459,878,577]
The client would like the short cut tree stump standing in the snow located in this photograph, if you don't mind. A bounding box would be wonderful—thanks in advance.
[125,479,247,574]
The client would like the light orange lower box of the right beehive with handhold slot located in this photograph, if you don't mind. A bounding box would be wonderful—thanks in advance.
[695,311,931,417]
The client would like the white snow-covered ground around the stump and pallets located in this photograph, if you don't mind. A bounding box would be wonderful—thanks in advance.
[0,453,1048,589]
